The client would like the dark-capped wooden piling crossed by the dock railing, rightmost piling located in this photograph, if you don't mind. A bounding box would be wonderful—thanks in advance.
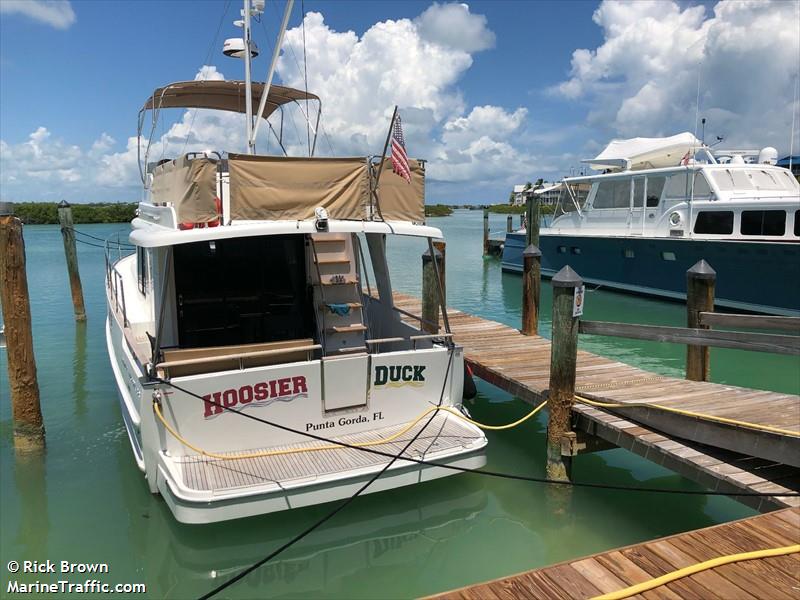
[686,260,717,381]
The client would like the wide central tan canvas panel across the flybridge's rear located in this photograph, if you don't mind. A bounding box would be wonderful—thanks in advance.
[228,154,369,221]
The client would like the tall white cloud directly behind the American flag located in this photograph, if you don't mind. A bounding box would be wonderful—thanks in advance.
[278,3,532,181]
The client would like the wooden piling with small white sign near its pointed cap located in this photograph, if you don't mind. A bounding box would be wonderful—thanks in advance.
[547,266,583,481]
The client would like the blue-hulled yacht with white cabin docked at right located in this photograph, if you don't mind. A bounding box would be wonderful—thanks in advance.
[502,133,800,316]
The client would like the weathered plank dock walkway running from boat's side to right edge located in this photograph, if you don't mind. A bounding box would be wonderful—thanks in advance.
[394,294,800,511]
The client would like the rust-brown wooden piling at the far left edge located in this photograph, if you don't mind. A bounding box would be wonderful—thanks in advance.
[0,215,44,452]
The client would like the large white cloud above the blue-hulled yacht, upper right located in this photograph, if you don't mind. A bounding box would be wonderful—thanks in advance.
[552,0,800,150]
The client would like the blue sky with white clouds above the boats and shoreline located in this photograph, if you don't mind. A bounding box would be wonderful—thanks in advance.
[0,0,800,202]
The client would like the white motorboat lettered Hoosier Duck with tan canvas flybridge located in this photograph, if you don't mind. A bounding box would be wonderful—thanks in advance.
[106,0,487,523]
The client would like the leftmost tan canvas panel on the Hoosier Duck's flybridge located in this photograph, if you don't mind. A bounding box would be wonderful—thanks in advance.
[151,156,219,223]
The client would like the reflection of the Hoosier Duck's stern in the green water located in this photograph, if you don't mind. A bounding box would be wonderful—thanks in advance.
[136,477,488,597]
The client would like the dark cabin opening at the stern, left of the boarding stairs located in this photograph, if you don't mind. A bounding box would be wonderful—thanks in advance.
[174,235,314,348]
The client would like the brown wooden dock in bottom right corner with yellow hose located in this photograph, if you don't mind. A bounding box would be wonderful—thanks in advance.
[432,508,800,600]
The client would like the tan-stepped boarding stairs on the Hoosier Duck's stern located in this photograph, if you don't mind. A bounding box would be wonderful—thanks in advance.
[309,233,367,356]
